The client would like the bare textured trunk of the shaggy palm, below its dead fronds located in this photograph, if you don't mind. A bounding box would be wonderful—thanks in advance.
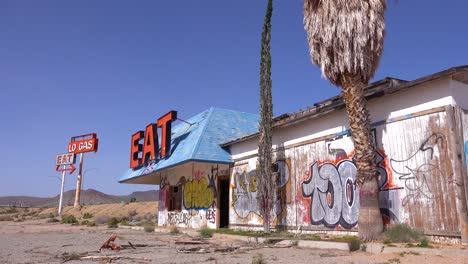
[342,76,383,241]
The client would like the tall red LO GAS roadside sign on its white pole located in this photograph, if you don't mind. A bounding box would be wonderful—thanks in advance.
[68,133,98,208]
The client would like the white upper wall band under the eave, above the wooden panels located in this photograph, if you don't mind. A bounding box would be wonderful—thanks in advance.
[230,78,460,160]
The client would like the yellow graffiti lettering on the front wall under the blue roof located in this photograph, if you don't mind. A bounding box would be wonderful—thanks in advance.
[183,178,214,210]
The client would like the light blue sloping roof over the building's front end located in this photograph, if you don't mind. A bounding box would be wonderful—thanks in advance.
[119,107,259,182]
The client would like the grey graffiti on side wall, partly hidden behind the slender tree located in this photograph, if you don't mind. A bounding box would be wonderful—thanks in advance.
[231,160,291,221]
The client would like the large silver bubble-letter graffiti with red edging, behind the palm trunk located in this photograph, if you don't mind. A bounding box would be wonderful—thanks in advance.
[302,149,401,229]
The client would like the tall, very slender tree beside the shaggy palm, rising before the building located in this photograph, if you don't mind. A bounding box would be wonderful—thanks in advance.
[257,0,276,233]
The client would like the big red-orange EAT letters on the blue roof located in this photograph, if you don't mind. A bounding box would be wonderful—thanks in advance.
[130,111,177,168]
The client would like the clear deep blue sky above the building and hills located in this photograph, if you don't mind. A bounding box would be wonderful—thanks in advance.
[0,0,468,196]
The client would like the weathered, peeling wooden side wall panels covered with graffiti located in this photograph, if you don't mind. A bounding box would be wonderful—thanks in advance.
[230,108,459,234]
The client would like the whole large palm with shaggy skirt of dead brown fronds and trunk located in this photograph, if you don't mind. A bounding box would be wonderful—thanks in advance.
[304,0,386,241]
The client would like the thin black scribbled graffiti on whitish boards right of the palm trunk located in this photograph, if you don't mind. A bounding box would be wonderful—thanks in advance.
[390,133,447,206]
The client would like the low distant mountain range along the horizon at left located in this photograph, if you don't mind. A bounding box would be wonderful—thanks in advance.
[0,189,159,207]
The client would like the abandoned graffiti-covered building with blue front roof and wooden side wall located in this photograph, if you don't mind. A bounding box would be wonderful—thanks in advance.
[119,66,468,237]
